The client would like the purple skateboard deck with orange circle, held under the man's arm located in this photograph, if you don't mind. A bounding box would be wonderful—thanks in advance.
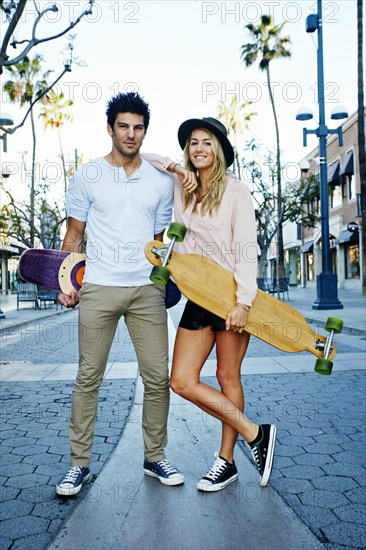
[18,248,86,294]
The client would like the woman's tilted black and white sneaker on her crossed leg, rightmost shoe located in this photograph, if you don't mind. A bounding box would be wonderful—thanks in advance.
[248,424,277,487]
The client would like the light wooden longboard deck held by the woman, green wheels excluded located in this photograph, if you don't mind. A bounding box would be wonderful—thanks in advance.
[145,241,336,359]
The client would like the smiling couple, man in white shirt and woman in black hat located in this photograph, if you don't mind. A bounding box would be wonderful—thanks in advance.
[56,92,276,496]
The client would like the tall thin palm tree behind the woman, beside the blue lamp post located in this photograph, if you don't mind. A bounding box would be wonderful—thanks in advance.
[241,15,291,276]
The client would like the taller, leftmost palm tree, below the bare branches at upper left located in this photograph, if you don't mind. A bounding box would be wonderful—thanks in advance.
[4,55,51,247]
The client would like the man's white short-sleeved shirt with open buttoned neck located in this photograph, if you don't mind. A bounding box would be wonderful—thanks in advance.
[66,158,173,286]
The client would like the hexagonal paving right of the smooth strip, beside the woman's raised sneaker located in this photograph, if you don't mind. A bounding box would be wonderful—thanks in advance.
[239,370,366,550]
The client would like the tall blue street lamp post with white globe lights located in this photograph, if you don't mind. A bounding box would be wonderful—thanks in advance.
[296,0,348,309]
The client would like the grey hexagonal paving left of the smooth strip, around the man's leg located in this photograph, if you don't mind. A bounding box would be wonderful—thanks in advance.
[0,312,136,550]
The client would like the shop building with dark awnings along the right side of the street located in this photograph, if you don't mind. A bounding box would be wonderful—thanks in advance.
[294,113,363,289]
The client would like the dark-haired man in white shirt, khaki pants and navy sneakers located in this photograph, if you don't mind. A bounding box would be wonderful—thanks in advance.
[56,92,194,496]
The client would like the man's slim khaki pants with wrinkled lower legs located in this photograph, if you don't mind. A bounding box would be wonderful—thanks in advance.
[69,283,169,467]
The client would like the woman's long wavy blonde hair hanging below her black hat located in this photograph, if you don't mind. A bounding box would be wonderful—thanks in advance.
[183,128,227,216]
